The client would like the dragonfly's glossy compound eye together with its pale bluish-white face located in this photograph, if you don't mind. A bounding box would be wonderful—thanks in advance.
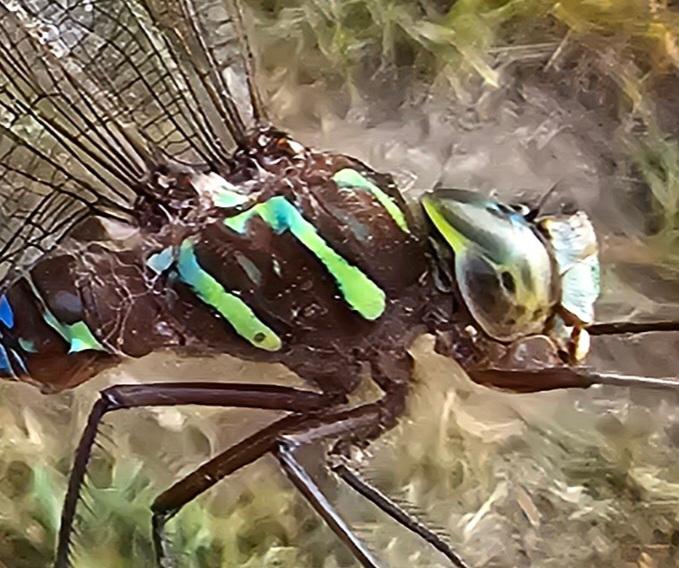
[423,189,599,360]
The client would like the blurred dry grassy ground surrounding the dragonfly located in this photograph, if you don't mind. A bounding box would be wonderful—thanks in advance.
[0,0,679,568]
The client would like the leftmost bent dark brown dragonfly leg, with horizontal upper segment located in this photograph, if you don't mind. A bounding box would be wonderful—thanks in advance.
[54,383,344,568]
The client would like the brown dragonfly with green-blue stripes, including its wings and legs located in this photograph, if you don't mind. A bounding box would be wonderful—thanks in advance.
[0,0,679,568]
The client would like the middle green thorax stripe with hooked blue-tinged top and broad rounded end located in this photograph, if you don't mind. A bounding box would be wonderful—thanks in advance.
[224,196,386,320]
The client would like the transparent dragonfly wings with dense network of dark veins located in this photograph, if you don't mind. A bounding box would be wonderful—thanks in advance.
[0,0,261,288]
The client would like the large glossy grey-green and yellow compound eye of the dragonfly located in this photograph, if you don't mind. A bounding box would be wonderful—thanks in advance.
[422,189,559,341]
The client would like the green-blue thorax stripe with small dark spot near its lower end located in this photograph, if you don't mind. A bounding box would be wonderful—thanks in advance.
[177,239,282,351]
